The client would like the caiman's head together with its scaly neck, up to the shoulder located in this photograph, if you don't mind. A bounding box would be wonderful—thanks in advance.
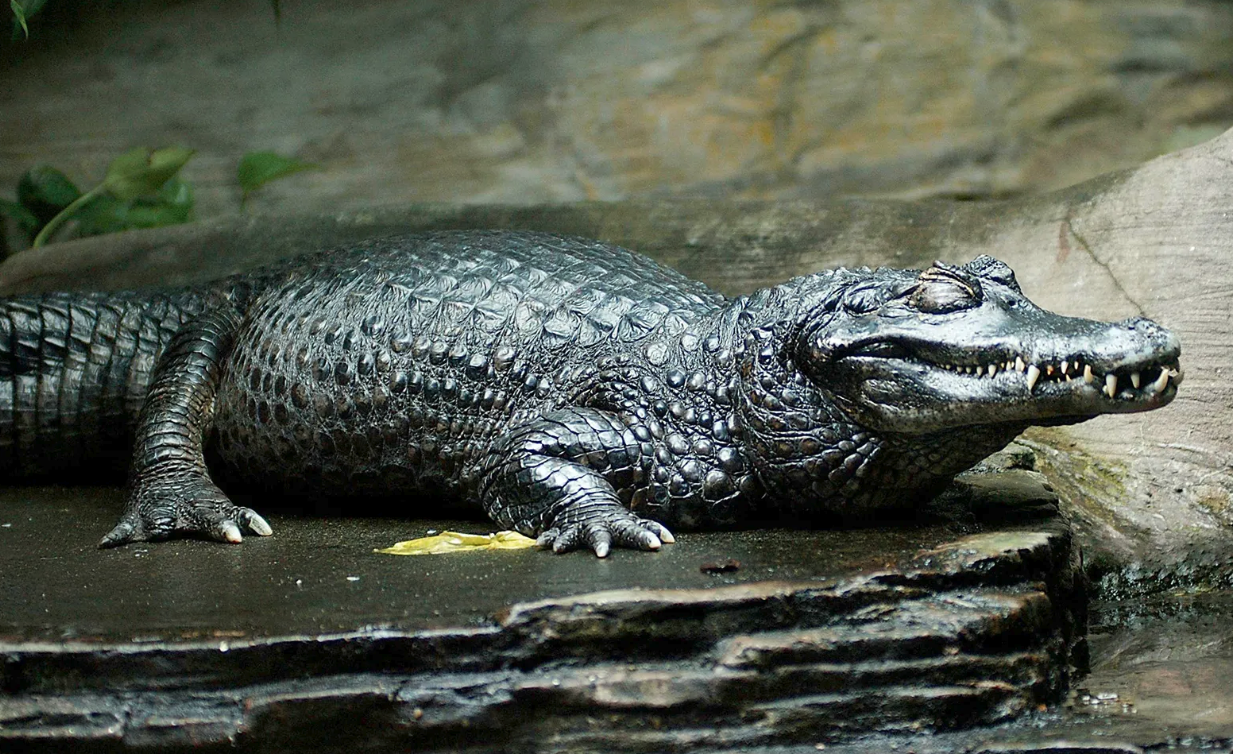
[745,256,1182,517]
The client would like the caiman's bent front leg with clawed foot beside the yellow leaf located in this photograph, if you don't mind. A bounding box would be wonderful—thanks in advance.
[481,409,676,558]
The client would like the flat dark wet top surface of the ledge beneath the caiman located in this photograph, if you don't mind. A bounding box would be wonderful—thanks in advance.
[0,487,954,641]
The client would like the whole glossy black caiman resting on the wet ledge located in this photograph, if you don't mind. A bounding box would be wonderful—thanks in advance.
[0,232,1182,557]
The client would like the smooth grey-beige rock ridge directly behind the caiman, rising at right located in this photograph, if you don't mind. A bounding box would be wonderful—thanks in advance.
[0,132,1233,593]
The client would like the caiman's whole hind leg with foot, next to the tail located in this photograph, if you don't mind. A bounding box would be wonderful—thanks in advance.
[99,301,271,547]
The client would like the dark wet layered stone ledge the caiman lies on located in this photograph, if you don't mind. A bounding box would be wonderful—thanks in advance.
[0,471,1085,752]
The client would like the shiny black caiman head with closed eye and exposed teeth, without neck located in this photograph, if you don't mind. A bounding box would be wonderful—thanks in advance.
[797,256,1181,434]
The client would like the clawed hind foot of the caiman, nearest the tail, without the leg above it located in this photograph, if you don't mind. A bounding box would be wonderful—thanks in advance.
[99,479,274,547]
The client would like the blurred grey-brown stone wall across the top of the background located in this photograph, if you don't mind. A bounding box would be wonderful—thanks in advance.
[0,0,1233,217]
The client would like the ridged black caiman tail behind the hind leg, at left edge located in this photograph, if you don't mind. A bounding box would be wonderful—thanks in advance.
[0,291,202,480]
